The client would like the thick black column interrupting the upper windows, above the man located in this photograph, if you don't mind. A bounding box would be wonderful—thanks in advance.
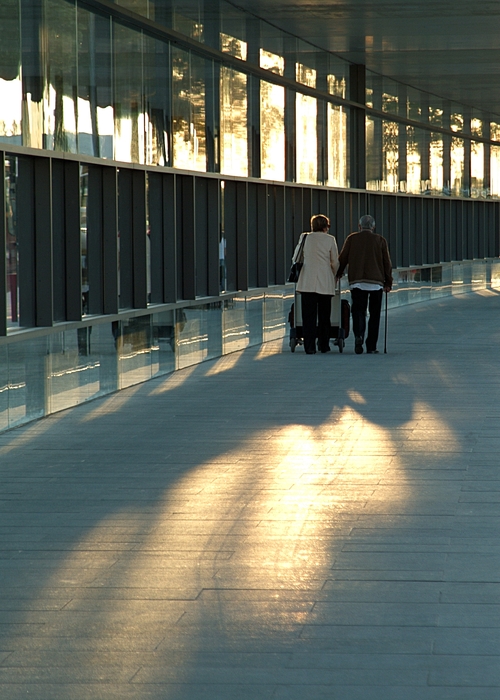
[349,64,366,189]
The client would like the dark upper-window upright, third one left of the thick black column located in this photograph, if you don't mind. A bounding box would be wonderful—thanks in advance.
[246,17,261,178]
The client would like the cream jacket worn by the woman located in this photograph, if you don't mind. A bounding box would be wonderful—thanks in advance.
[292,231,339,295]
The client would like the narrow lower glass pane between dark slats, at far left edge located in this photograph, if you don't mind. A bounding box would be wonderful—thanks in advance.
[5,155,19,328]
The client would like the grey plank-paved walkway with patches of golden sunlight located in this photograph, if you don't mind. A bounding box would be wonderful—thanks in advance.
[0,292,500,700]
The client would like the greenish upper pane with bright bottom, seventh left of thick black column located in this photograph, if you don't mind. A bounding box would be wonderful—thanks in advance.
[113,22,145,163]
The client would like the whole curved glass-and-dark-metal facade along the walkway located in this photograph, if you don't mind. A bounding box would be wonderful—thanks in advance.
[0,0,500,429]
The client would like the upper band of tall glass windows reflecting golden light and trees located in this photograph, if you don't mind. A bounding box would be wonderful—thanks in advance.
[0,0,500,198]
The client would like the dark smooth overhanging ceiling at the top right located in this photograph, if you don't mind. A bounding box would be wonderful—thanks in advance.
[234,0,500,114]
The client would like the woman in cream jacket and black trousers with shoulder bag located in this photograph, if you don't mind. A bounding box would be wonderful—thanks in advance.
[293,214,339,355]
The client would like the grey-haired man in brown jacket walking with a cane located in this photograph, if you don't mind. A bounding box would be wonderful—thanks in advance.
[337,214,392,355]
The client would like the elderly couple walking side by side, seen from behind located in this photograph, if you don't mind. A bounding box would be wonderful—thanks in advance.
[293,214,392,355]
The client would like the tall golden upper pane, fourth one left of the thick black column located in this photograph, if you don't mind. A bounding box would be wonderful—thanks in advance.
[220,64,248,177]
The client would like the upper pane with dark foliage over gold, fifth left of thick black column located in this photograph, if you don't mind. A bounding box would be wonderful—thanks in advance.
[172,48,207,171]
